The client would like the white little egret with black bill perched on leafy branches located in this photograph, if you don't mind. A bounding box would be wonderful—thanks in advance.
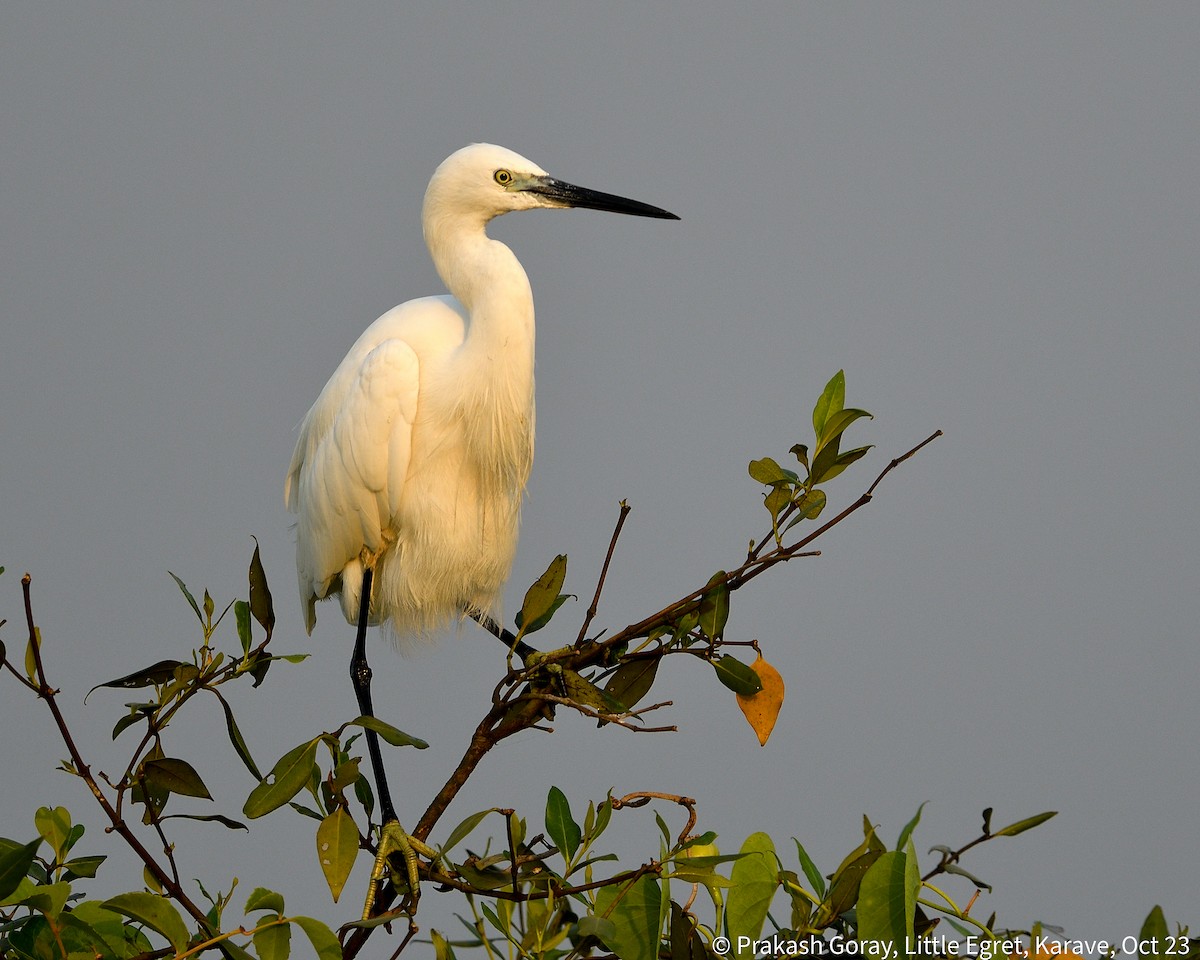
[280,144,678,912]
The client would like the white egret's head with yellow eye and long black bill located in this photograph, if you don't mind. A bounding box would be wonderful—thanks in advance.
[425,143,679,224]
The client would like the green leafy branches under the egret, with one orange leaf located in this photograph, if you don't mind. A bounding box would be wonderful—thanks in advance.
[0,372,1147,960]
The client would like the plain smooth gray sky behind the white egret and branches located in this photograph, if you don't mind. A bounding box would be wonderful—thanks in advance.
[0,0,1200,937]
